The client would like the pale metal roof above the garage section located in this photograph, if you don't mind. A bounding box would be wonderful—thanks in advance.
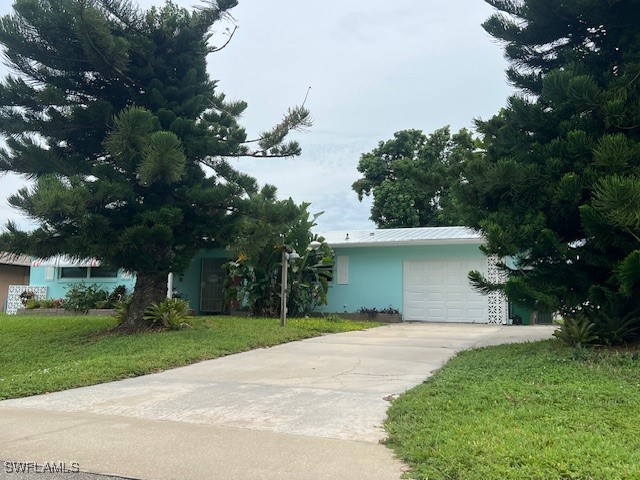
[320,227,483,247]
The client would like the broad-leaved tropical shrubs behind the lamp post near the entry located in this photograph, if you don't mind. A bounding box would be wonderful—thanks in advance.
[225,199,333,316]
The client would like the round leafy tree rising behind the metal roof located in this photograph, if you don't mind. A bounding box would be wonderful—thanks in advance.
[353,127,475,228]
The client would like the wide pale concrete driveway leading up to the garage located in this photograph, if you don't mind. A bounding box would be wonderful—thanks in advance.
[0,323,553,480]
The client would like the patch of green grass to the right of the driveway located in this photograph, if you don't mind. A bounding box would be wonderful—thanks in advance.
[386,340,640,480]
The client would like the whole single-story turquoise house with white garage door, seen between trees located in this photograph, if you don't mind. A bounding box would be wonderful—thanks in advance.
[23,227,540,324]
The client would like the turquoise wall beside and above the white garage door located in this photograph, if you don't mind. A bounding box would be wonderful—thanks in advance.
[322,244,484,313]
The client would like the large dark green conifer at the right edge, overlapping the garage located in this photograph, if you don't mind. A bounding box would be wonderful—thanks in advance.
[457,0,640,338]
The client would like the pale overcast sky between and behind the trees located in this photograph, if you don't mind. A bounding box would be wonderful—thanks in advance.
[0,0,512,232]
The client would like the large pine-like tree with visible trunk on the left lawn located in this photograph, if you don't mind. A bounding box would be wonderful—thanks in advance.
[0,0,310,328]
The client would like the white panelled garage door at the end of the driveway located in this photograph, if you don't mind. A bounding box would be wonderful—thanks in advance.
[402,259,489,323]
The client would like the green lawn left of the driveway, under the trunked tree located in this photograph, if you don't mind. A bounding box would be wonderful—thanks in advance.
[0,315,378,400]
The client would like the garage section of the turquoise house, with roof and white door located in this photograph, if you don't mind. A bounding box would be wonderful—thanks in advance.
[323,227,509,323]
